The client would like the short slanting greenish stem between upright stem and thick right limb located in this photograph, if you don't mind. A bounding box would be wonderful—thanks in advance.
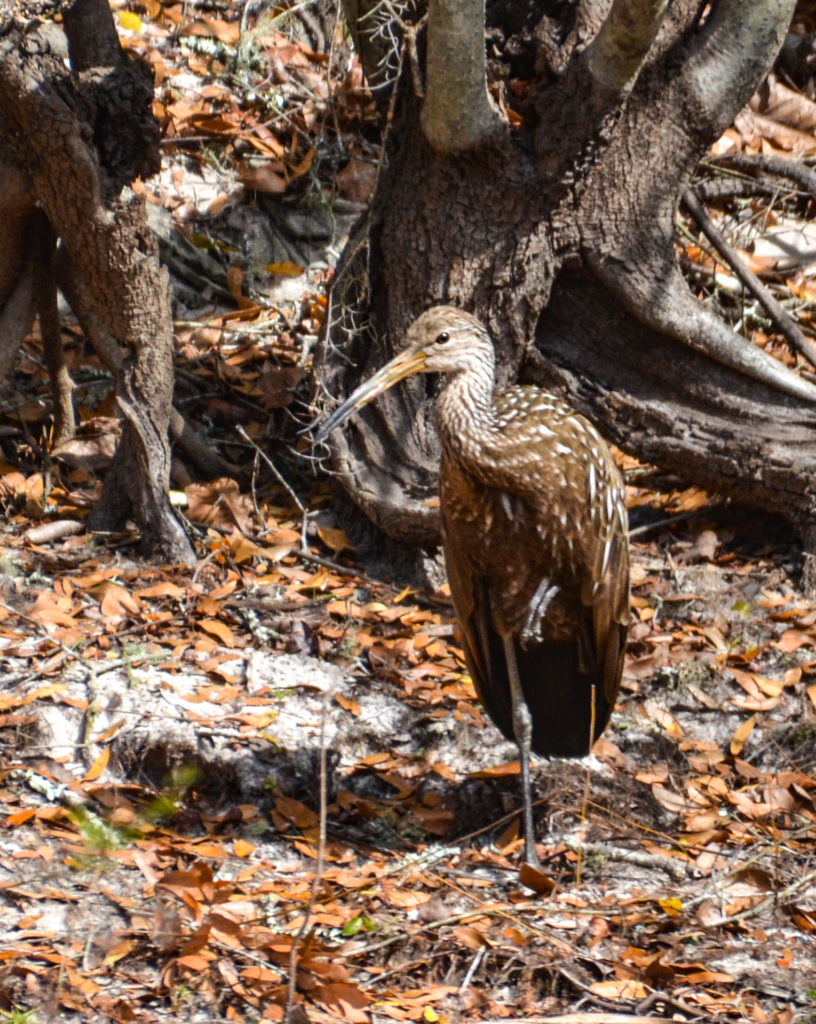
[585,0,669,98]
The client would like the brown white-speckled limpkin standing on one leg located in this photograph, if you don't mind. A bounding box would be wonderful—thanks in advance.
[315,306,629,864]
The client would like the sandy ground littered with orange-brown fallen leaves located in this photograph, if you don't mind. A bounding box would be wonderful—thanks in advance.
[0,0,816,1024]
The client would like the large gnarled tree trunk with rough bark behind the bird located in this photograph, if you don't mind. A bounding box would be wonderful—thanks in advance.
[319,0,816,569]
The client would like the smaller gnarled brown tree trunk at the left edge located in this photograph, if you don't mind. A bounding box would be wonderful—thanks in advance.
[0,0,195,562]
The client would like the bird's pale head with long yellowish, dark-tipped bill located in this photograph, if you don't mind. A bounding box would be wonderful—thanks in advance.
[314,306,493,442]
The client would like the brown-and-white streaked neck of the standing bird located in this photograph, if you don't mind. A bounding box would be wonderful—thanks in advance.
[436,366,498,465]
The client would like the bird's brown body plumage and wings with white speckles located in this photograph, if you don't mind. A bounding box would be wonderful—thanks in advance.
[440,388,629,755]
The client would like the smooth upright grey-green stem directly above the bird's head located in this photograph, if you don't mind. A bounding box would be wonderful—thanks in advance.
[422,0,504,155]
